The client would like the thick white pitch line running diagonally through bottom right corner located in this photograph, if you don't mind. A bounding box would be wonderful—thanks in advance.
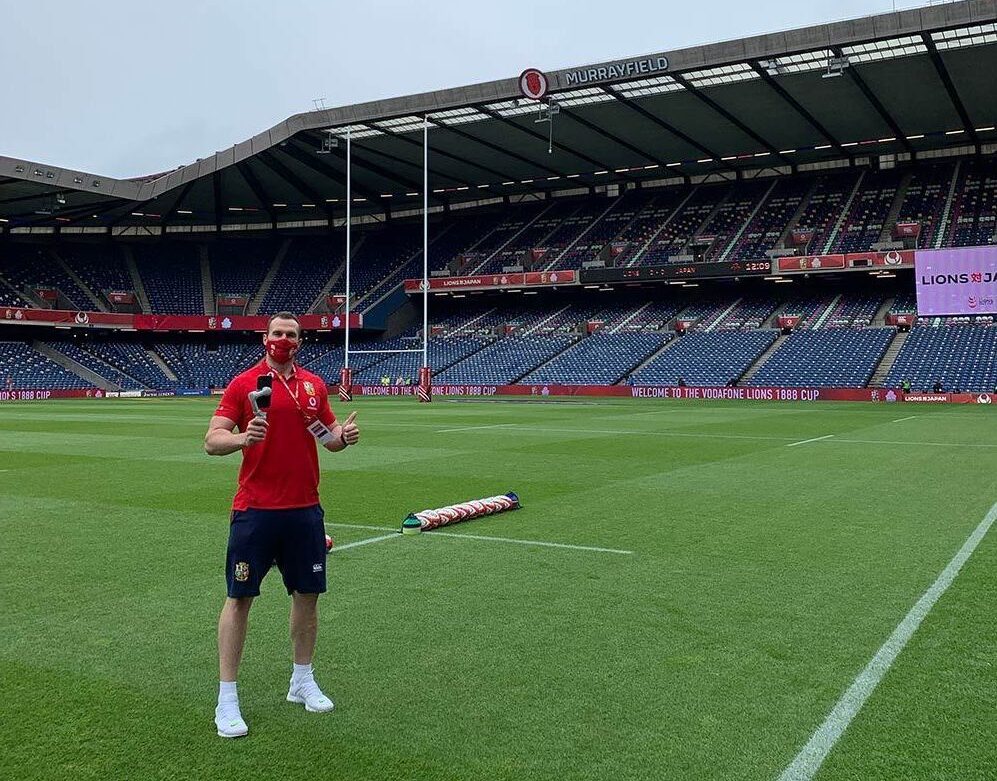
[779,504,997,781]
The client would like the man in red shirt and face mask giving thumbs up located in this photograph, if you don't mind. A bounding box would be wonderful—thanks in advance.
[204,312,360,738]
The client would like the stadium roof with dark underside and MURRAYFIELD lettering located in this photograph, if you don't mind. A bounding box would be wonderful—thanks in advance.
[0,0,997,234]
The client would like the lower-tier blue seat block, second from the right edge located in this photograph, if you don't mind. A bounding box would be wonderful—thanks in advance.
[748,328,896,388]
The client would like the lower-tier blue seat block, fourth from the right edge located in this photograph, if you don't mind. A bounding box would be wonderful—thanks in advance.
[521,331,672,385]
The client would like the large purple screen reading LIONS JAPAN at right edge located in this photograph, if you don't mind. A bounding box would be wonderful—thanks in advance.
[914,247,997,317]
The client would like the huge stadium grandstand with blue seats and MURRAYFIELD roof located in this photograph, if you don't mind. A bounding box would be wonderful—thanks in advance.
[0,0,997,393]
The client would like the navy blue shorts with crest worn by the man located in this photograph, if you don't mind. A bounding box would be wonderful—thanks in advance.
[225,504,326,597]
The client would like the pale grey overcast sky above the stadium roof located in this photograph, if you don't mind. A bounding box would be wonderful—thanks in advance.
[0,0,940,177]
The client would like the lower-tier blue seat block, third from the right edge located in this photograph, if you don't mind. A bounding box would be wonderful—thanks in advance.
[630,330,778,385]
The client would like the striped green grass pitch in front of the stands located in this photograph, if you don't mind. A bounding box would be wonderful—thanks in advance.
[0,399,997,781]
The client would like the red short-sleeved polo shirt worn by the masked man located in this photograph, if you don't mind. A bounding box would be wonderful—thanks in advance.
[215,360,336,510]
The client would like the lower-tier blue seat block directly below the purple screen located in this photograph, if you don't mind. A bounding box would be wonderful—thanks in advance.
[885,325,997,393]
